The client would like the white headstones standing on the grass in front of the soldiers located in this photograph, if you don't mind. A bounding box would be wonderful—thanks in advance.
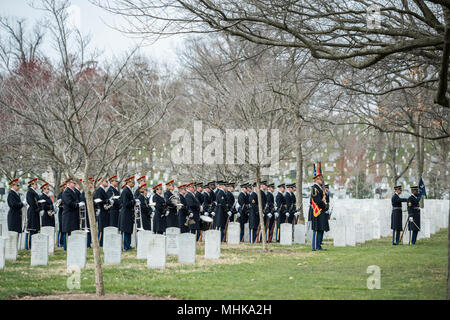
[0,199,449,270]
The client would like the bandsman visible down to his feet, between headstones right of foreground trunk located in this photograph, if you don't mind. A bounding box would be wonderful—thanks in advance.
[119,176,136,251]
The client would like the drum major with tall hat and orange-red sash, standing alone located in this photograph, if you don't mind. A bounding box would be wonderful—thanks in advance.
[311,162,330,251]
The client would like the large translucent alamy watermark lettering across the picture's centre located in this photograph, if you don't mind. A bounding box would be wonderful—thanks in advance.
[170,121,280,175]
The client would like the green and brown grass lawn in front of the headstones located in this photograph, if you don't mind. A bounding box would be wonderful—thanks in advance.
[0,229,448,300]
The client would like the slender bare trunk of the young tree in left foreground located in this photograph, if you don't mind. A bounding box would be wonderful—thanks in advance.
[83,161,105,296]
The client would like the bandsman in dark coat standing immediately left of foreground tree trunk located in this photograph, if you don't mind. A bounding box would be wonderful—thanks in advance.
[62,178,86,251]
